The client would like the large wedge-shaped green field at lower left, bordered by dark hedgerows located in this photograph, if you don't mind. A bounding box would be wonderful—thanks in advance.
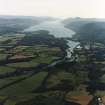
[0,72,47,96]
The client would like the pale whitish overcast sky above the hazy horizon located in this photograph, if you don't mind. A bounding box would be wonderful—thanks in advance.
[0,0,105,18]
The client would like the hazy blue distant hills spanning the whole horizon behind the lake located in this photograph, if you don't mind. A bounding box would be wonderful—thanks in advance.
[0,15,105,35]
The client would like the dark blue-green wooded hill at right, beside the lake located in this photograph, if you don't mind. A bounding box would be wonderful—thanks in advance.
[74,22,105,48]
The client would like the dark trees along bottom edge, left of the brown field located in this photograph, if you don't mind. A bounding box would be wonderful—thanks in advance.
[17,93,65,105]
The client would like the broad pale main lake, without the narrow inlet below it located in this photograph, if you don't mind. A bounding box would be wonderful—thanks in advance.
[25,20,75,37]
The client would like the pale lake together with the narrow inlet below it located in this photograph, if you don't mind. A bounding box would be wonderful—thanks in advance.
[25,20,79,58]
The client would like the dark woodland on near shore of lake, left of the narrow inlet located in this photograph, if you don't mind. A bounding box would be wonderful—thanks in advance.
[18,30,68,50]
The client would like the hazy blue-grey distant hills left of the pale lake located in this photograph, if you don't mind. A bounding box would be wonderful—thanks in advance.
[0,15,54,34]
